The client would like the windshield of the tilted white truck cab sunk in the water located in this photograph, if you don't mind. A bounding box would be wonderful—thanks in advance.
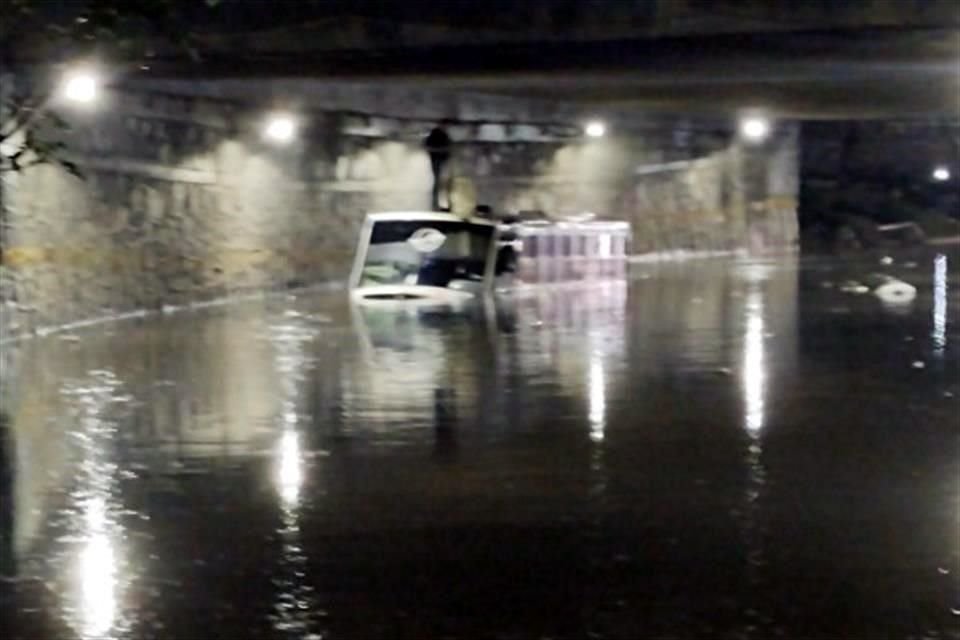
[358,220,494,287]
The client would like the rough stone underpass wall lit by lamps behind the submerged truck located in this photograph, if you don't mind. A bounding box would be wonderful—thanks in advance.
[2,85,796,337]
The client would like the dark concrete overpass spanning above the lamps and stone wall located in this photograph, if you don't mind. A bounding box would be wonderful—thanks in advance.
[11,0,960,118]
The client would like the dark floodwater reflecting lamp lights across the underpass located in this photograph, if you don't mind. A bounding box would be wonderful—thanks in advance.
[0,251,960,640]
